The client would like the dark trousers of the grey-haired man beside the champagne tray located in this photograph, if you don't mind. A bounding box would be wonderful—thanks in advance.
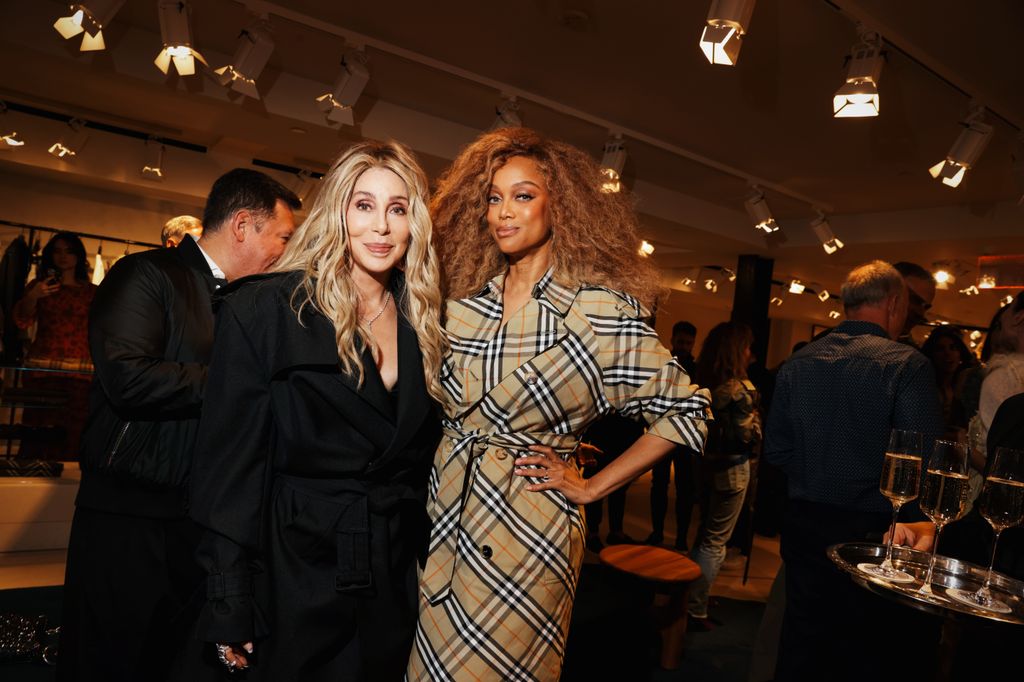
[775,500,941,682]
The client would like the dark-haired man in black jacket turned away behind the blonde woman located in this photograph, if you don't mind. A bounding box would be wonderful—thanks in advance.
[57,168,300,682]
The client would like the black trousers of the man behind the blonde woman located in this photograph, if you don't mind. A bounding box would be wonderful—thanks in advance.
[56,507,205,682]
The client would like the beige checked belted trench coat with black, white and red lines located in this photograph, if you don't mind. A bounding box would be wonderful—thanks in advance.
[408,272,710,681]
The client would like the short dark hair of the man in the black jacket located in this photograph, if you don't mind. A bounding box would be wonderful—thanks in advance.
[203,168,302,233]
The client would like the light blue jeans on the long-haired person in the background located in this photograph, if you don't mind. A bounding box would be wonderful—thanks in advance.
[688,462,751,619]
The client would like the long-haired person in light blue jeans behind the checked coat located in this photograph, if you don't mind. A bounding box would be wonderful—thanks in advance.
[688,322,761,625]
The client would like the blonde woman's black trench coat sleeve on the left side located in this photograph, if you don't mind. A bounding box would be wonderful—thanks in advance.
[189,301,272,642]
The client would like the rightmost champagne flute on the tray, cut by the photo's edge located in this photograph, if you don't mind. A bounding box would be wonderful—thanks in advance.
[946,447,1024,613]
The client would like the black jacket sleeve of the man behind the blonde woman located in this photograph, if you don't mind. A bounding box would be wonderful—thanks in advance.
[89,258,206,411]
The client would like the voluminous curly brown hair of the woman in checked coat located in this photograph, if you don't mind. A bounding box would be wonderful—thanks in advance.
[430,128,662,308]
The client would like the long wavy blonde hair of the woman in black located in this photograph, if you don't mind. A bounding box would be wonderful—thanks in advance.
[273,141,445,401]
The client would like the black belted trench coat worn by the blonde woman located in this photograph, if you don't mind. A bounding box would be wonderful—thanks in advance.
[190,273,440,682]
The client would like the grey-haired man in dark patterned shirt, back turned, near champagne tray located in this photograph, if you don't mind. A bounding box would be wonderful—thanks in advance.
[764,261,942,681]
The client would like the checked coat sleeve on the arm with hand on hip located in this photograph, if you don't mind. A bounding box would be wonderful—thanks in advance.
[587,286,711,453]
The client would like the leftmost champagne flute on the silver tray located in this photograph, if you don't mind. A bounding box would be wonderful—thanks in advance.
[857,429,924,583]
